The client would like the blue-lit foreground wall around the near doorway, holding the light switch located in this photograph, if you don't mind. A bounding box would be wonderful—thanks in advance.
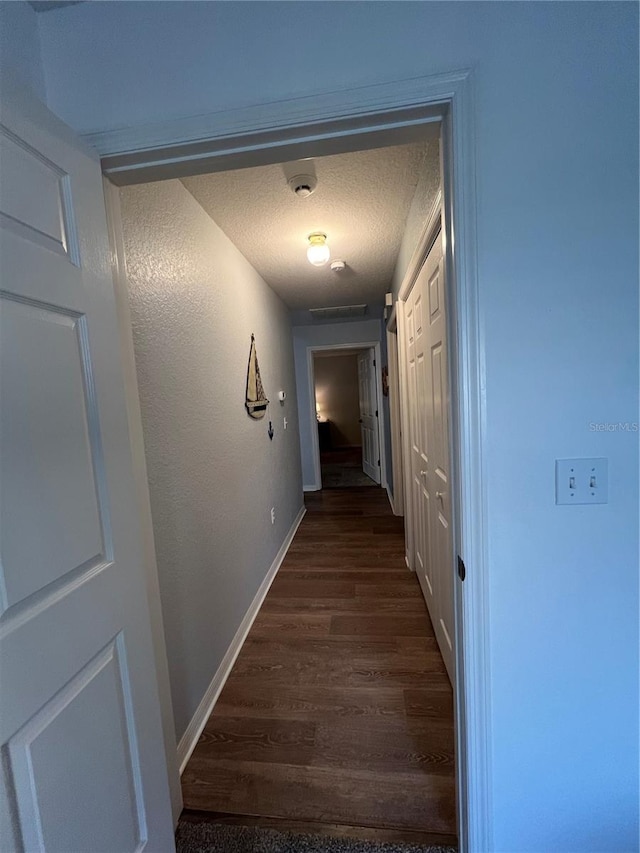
[32,2,638,853]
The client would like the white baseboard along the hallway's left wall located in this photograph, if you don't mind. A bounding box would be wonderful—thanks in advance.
[178,507,306,775]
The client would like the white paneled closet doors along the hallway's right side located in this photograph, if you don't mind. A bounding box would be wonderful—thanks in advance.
[403,225,455,682]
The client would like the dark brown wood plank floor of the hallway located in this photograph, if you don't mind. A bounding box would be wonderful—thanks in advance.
[182,488,456,844]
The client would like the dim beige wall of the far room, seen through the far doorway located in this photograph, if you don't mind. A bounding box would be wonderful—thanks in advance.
[313,355,362,447]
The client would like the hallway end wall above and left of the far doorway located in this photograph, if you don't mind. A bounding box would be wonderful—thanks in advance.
[293,320,382,489]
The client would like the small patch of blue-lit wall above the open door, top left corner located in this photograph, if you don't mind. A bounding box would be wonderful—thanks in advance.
[0,0,45,101]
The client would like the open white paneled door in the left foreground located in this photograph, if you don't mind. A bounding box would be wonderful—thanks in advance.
[0,83,173,853]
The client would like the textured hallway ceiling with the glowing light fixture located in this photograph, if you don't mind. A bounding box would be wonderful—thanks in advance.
[183,141,439,310]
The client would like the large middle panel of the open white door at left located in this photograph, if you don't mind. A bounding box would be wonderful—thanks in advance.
[0,294,106,611]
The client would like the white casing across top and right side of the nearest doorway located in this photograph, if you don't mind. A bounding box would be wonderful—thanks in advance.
[105,75,488,847]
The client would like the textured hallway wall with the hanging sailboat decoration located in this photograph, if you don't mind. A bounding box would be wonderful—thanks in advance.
[121,181,302,739]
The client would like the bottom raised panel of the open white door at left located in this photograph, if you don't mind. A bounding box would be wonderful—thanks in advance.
[8,634,146,853]
